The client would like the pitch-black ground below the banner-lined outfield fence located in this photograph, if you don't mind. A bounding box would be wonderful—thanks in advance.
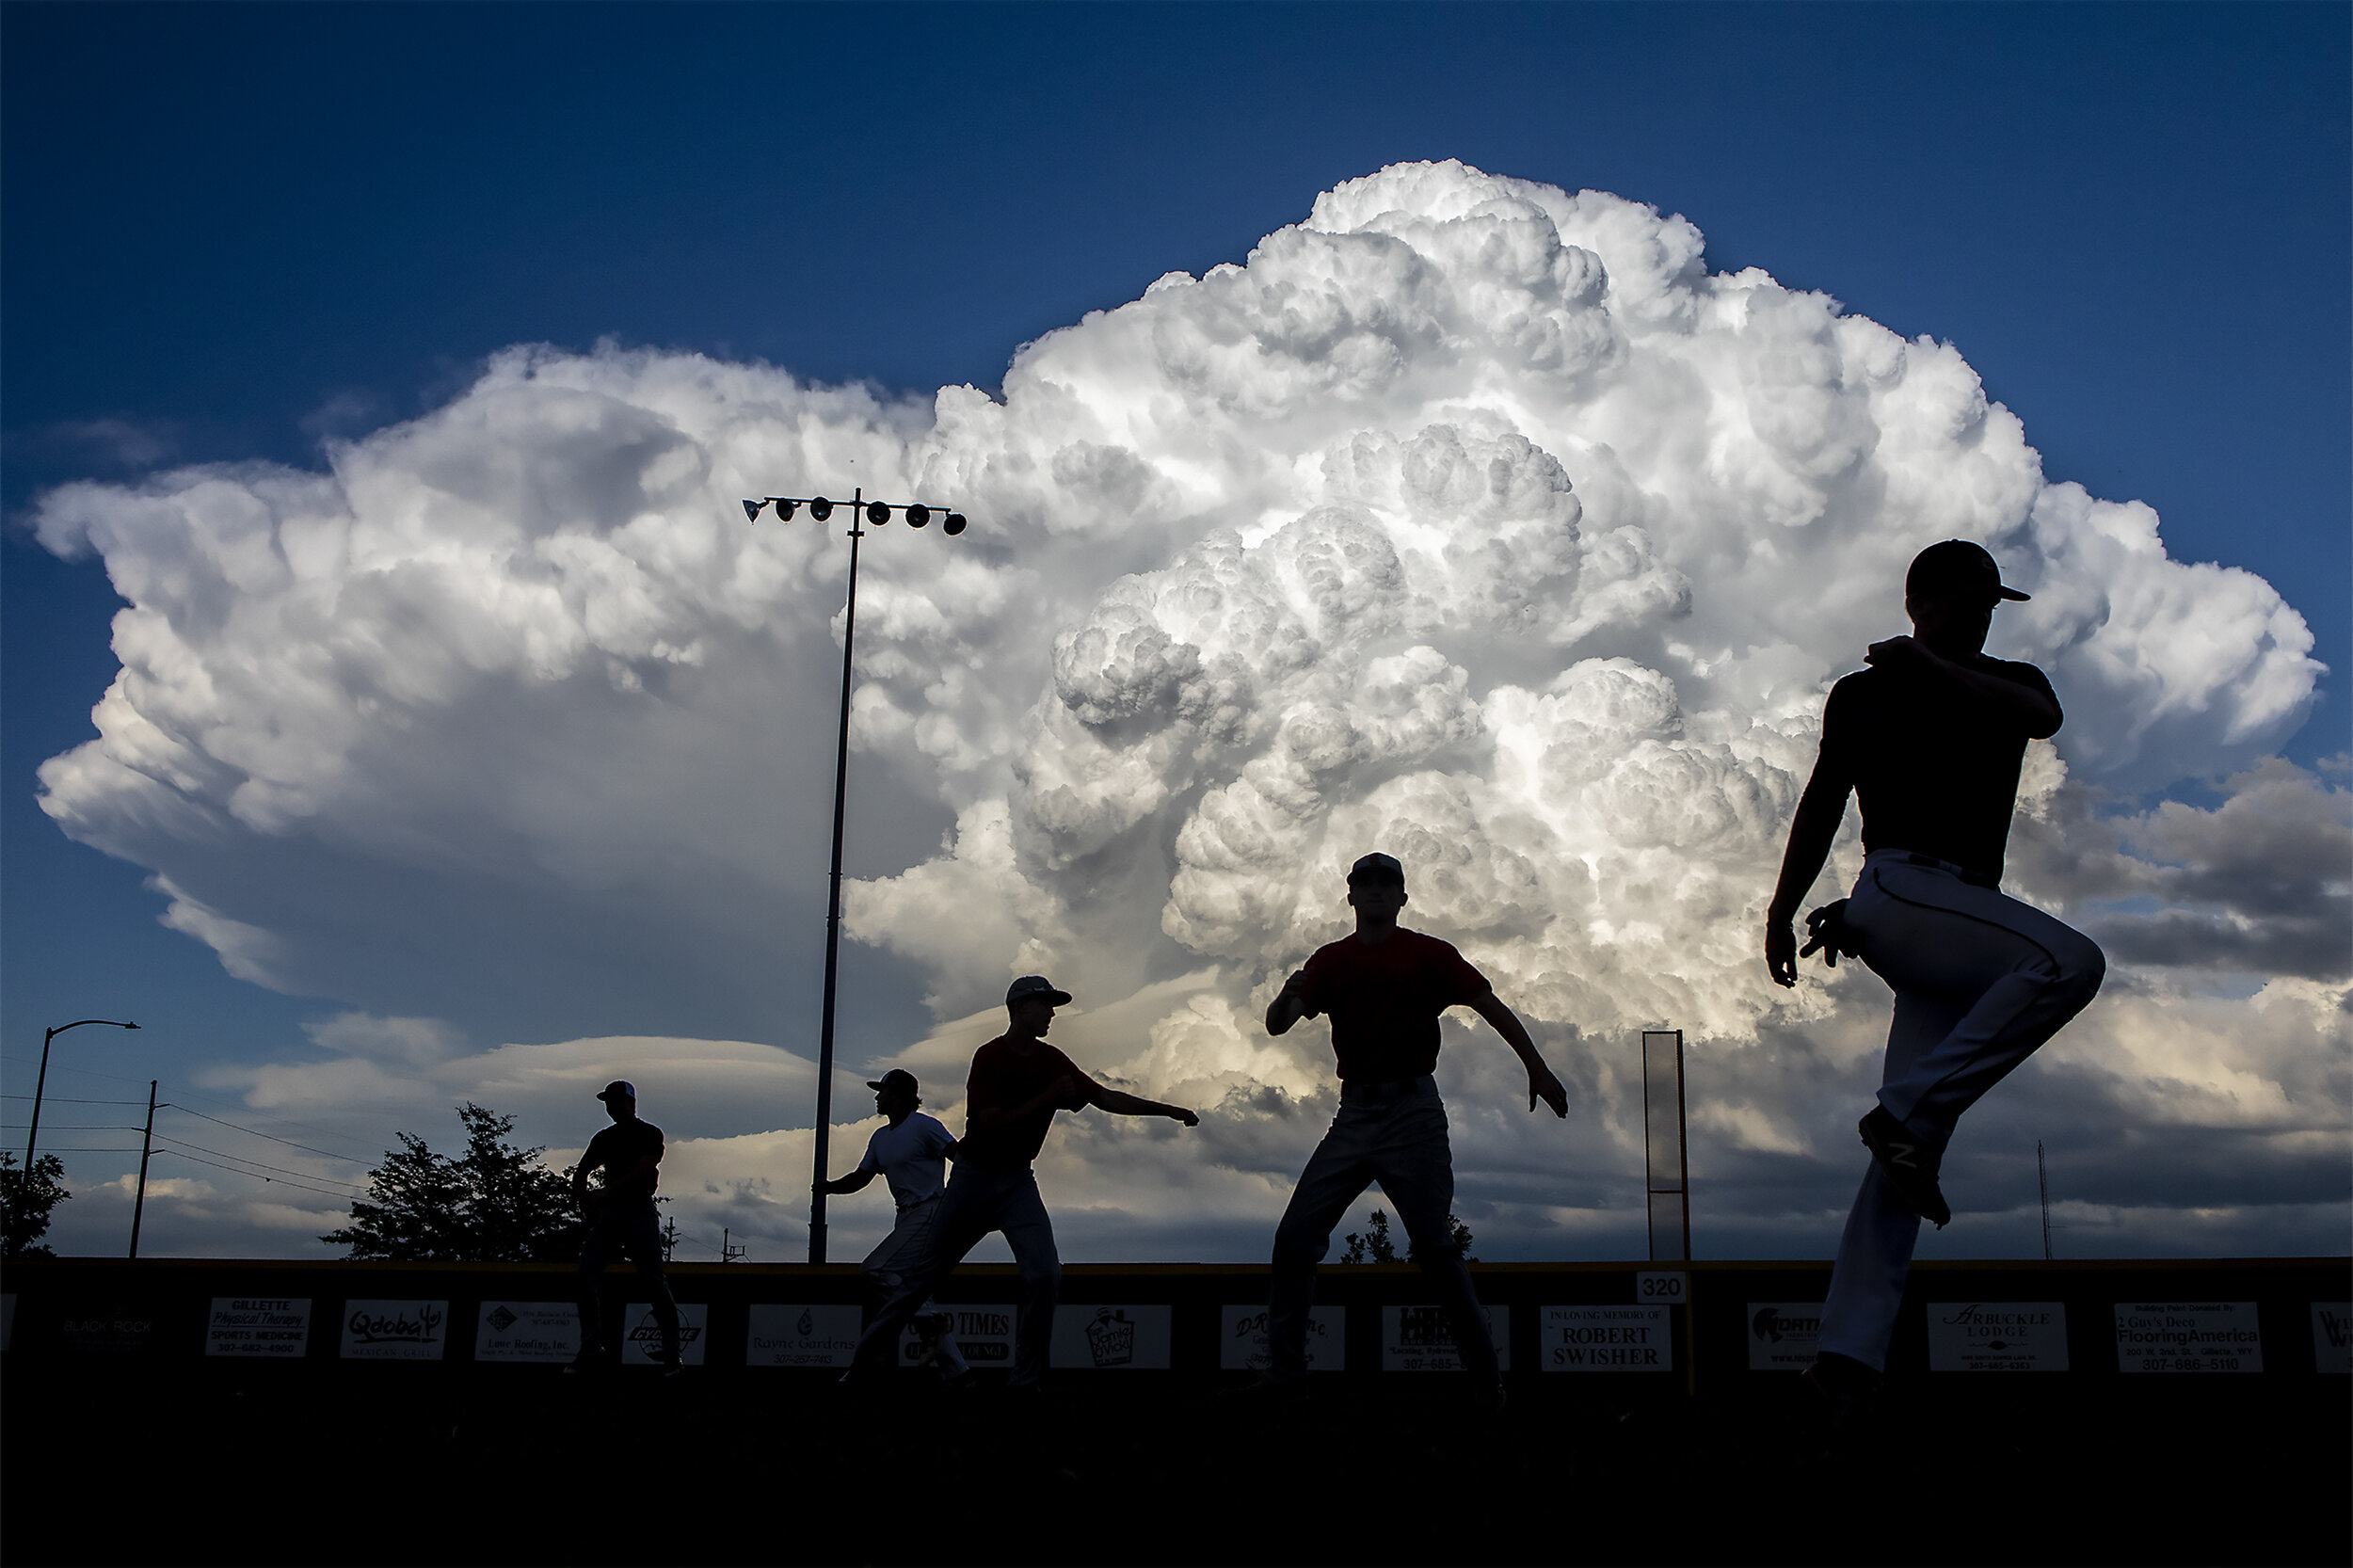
[0,1363,2353,1565]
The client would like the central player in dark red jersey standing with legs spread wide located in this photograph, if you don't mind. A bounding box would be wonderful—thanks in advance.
[1259,855,1570,1403]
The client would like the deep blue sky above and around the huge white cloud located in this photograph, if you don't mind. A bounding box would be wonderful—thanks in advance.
[0,5,2353,1176]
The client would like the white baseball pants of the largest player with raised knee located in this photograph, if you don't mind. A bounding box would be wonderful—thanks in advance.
[1821,850,2108,1370]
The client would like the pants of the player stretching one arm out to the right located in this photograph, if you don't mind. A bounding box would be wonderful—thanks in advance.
[852,1160,1062,1389]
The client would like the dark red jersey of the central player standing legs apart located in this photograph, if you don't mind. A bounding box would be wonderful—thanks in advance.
[1304,925,1495,1080]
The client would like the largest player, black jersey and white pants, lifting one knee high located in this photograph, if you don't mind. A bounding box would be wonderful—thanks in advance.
[1765,539,2108,1415]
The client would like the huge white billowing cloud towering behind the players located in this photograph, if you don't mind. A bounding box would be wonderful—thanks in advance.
[38,163,2353,1245]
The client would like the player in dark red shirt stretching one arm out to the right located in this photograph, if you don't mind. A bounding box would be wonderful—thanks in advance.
[845,975,1200,1391]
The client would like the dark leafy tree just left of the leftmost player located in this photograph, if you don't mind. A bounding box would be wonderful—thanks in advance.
[320,1099,577,1262]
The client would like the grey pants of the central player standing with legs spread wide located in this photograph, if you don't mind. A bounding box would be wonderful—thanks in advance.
[1266,1074,1497,1382]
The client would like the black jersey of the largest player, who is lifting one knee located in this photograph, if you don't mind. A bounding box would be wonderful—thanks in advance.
[1805,654,2059,888]
